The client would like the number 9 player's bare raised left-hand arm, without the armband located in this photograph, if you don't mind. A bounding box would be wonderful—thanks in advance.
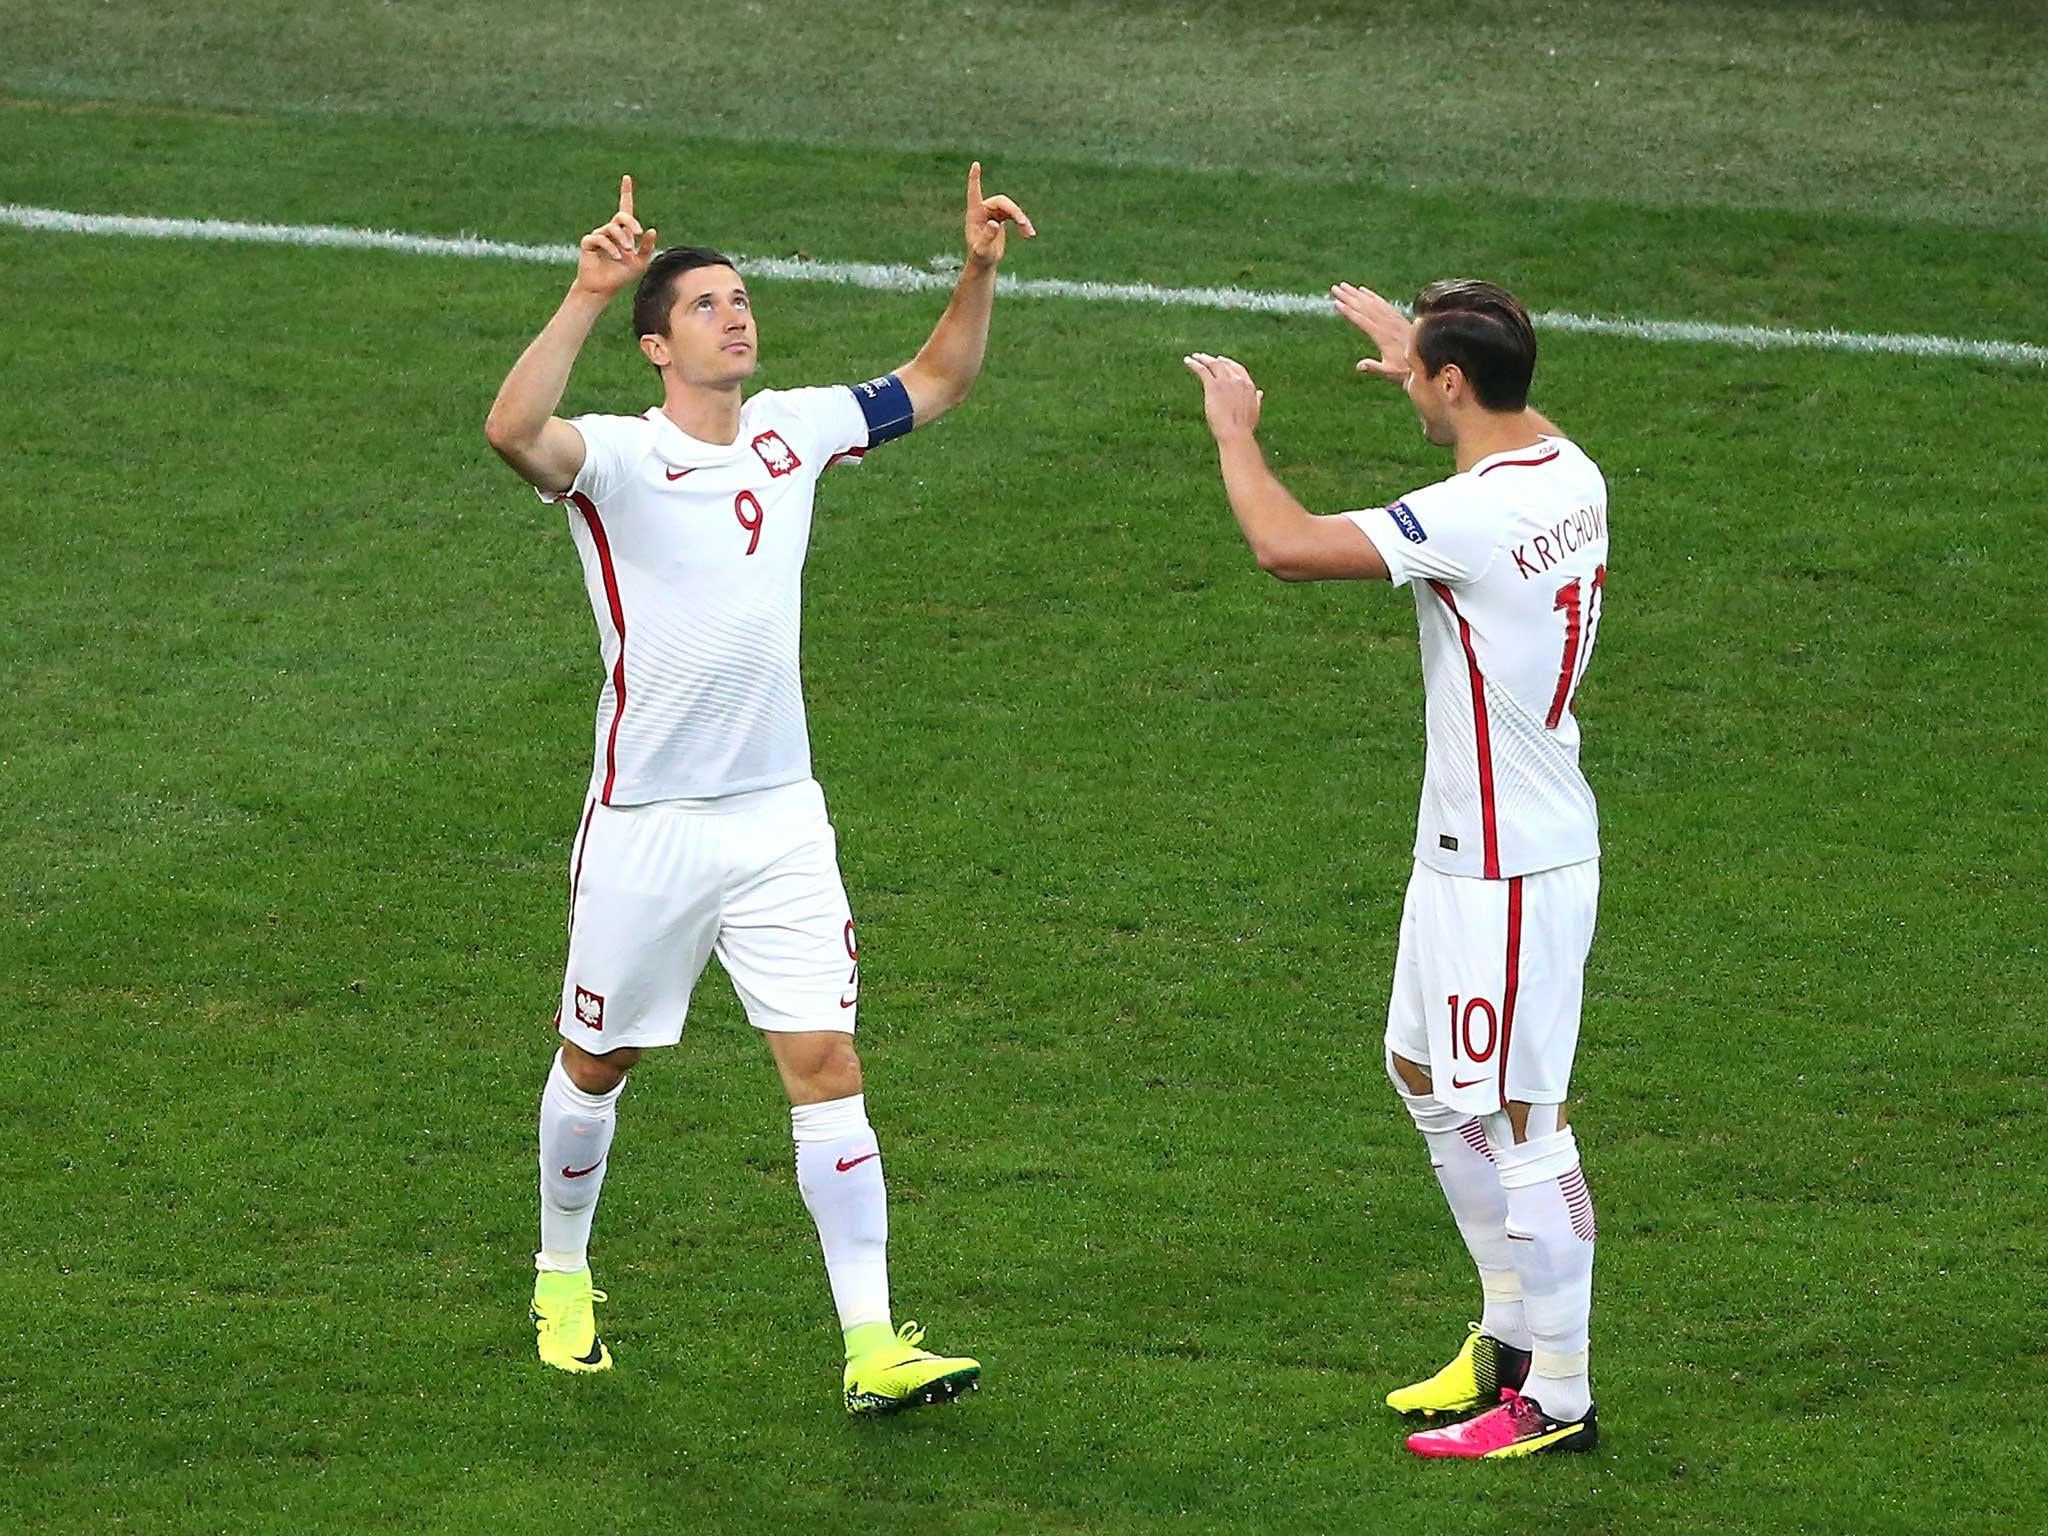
[483,176,655,492]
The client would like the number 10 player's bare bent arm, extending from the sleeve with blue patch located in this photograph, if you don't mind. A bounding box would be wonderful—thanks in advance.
[1184,352,1386,582]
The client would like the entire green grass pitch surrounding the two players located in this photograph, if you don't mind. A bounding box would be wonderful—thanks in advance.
[0,0,2048,1536]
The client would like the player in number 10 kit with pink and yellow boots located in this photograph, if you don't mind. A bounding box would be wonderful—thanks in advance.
[1188,281,1608,1456]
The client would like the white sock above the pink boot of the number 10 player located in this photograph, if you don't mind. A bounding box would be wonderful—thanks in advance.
[1499,1126,1595,1419]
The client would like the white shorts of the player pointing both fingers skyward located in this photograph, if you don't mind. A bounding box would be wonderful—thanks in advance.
[555,780,860,1055]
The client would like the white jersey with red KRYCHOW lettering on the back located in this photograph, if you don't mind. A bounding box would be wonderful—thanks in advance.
[1346,438,1608,881]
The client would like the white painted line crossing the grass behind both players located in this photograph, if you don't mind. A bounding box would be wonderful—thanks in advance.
[0,203,2048,369]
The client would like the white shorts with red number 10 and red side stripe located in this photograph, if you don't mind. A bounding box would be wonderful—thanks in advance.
[1386,858,1599,1114]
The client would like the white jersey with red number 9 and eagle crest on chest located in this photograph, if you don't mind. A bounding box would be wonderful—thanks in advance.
[541,381,907,805]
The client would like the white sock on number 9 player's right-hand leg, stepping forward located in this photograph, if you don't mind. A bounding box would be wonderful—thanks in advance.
[788,1094,889,1331]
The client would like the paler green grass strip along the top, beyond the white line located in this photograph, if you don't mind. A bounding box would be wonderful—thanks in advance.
[0,0,2048,233]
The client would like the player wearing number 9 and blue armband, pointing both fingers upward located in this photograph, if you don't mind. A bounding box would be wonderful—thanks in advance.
[483,164,1034,1413]
